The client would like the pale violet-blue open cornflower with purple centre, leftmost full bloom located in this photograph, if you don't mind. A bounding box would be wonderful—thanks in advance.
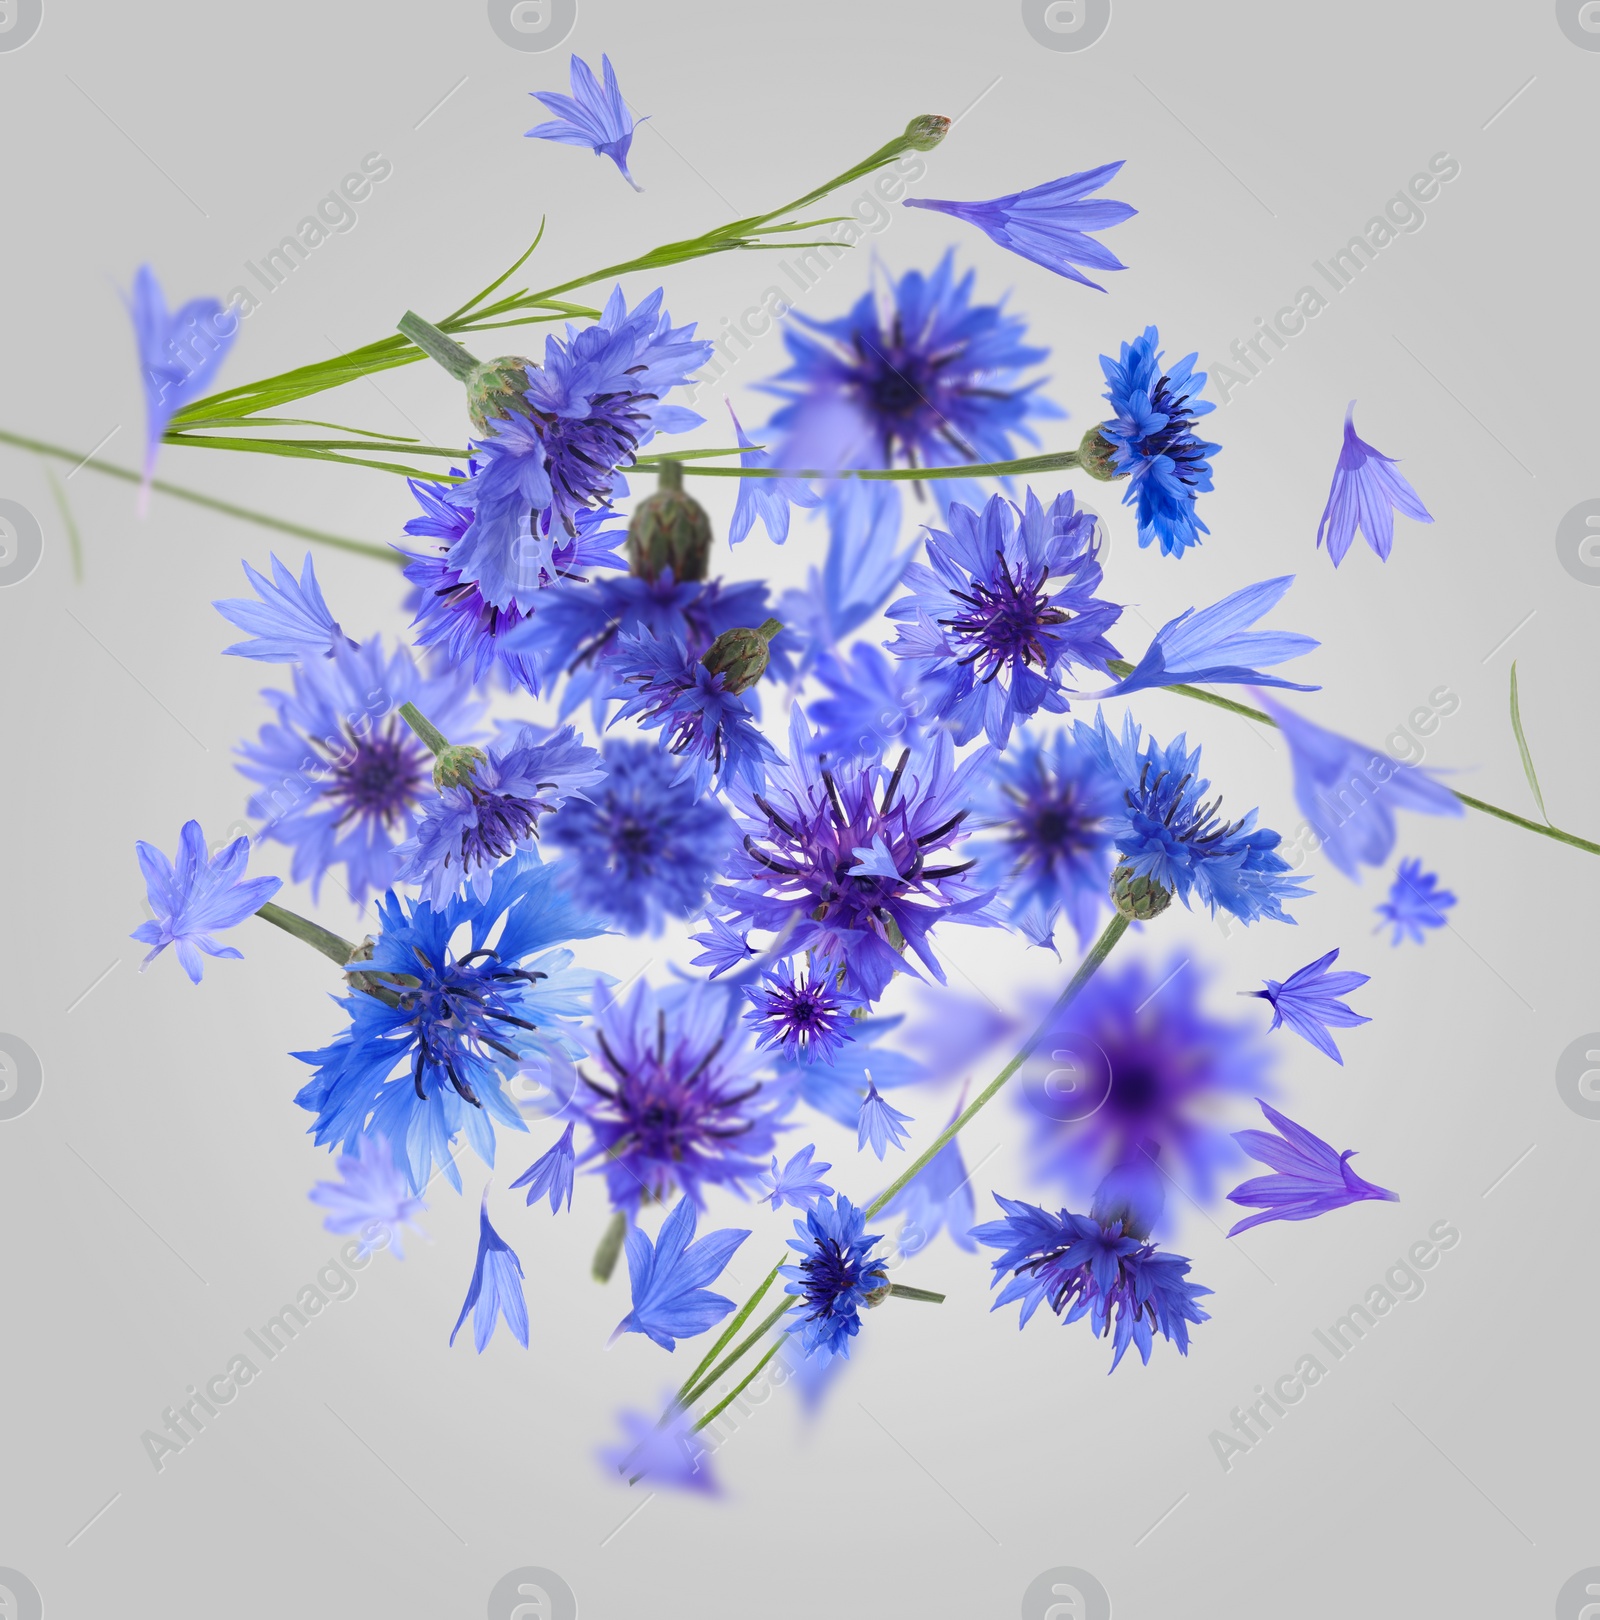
[238,637,483,906]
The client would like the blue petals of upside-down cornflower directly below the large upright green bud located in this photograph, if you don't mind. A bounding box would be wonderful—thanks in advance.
[507,569,774,726]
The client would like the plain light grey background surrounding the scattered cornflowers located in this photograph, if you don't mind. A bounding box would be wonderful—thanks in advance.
[0,0,1600,1620]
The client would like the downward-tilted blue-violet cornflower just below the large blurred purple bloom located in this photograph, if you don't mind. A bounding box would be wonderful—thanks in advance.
[972,1166,1211,1372]
